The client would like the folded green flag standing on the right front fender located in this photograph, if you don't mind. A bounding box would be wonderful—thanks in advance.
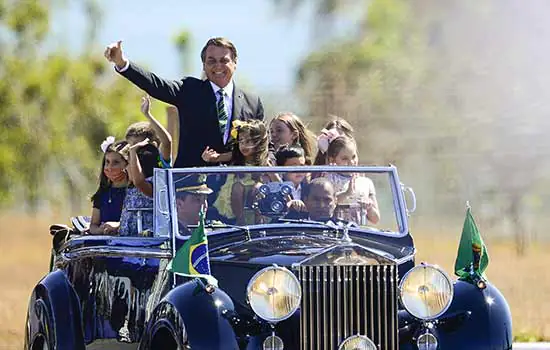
[455,207,489,280]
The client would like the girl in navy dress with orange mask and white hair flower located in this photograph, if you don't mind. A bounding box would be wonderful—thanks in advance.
[89,136,128,235]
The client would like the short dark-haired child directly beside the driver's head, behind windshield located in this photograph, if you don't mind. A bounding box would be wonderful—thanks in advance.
[275,145,308,211]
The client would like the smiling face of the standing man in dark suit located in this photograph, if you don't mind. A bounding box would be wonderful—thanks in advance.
[203,45,237,88]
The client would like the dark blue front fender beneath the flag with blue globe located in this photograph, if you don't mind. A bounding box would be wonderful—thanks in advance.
[139,279,239,350]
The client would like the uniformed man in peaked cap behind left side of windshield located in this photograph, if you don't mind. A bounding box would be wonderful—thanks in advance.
[174,174,213,236]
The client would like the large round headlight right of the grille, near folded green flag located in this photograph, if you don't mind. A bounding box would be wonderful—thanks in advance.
[399,265,453,320]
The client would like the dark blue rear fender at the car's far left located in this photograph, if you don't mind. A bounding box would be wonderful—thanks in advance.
[25,270,85,350]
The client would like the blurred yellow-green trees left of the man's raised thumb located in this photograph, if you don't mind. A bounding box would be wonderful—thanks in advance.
[0,0,144,214]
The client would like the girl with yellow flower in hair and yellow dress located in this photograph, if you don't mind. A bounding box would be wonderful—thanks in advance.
[214,120,268,224]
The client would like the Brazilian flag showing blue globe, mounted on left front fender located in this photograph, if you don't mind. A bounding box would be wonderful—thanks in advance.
[168,210,217,285]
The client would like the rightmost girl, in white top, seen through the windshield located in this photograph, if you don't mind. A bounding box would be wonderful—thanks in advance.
[325,136,380,224]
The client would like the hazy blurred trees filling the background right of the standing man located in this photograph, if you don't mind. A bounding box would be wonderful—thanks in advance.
[280,0,550,254]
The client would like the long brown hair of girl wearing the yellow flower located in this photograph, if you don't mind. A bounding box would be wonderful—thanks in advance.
[231,119,269,166]
